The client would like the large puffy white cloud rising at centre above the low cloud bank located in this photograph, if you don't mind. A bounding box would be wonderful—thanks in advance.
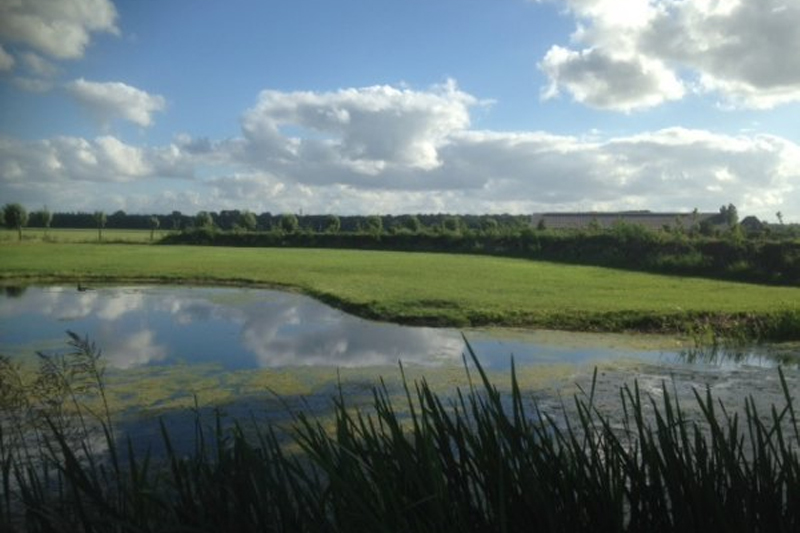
[242,81,477,175]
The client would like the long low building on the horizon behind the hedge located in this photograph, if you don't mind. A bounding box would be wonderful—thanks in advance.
[531,211,725,230]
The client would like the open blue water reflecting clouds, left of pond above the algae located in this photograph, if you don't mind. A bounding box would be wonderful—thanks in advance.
[0,287,463,369]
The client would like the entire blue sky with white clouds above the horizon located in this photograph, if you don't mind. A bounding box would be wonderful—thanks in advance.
[0,0,800,222]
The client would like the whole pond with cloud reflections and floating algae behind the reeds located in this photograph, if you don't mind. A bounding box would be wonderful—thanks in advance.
[0,286,800,448]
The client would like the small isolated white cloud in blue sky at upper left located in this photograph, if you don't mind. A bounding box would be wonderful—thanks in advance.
[67,78,166,127]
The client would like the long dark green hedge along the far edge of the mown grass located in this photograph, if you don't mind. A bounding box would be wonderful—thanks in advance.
[162,224,800,287]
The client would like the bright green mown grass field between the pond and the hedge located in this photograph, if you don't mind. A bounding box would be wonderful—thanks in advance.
[0,242,800,339]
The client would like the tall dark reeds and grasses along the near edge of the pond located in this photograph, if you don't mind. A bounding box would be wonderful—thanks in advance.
[0,337,800,533]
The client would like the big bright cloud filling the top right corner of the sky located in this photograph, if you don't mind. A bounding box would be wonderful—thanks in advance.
[539,0,800,111]
